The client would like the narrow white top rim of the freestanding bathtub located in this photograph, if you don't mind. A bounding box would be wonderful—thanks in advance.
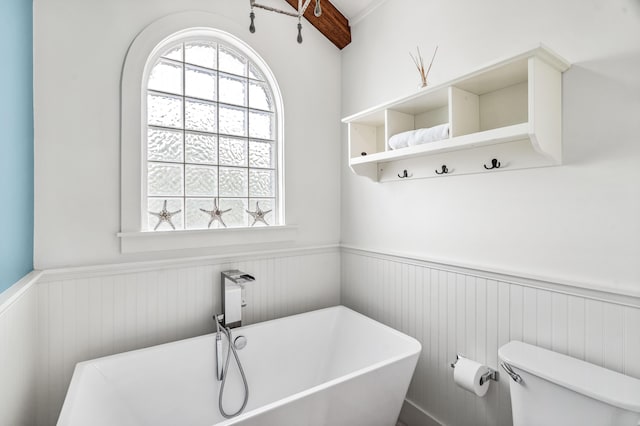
[57,305,422,426]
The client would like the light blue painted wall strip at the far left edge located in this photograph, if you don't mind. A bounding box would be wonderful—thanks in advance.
[0,0,33,292]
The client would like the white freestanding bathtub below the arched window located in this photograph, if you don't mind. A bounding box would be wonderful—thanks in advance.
[58,306,421,426]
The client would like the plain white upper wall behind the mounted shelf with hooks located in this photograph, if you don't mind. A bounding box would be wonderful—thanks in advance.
[341,0,640,294]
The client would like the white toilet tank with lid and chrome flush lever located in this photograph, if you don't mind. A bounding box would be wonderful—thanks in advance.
[498,341,640,426]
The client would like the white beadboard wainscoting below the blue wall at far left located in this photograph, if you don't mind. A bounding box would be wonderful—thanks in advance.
[0,272,40,426]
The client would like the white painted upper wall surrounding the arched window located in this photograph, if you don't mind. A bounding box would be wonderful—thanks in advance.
[34,0,340,269]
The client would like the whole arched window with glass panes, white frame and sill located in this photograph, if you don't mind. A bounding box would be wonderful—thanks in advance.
[118,11,297,253]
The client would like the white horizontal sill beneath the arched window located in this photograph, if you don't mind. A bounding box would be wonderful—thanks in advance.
[117,225,298,253]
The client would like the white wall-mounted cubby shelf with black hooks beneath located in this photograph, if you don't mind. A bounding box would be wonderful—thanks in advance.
[342,46,570,182]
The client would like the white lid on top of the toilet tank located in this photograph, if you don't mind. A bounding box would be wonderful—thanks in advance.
[498,340,640,413]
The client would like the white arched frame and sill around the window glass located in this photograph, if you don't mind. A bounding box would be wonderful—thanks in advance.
[117,12,297,253]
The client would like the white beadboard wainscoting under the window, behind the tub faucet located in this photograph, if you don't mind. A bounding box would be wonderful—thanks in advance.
[35,246,340,425]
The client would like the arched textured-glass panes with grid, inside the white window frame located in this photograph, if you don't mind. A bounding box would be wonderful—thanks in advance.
[141,35,281,231]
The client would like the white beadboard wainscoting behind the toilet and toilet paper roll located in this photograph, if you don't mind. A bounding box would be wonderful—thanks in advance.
[341,248,640,426]
